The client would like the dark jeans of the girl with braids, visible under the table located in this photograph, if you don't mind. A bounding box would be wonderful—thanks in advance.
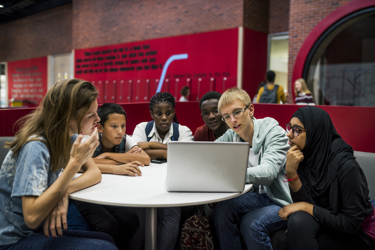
[157,207,182,250]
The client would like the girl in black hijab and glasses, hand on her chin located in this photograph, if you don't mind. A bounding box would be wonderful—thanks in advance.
[277,106,375,250]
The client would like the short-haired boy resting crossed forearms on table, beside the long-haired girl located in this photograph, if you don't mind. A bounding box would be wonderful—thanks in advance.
[74,103,150,249]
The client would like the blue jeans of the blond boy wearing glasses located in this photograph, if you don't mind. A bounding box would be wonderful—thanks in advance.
[214,192,287,250]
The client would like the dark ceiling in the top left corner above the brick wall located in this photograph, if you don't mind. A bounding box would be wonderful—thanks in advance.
[0,0,72,25]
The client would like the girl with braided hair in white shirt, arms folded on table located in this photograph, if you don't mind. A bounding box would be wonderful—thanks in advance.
[132,92,194,250]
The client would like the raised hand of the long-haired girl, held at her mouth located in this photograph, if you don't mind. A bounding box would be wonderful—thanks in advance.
[70,128,99,171]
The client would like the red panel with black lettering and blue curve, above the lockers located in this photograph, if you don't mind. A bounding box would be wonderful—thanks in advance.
[74,28,238,83]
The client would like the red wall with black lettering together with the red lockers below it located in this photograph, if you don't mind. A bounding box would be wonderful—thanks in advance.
[75,28,238,103]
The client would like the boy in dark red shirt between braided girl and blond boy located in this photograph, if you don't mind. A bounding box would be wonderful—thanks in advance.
[194,91,228,141]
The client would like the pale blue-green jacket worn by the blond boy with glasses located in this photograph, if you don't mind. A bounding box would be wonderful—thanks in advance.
[216,117,292,206]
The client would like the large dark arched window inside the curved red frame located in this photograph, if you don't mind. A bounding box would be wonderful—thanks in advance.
[303,8,375,107]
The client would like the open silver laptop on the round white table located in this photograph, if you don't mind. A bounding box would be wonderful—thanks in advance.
[167,141,250,192]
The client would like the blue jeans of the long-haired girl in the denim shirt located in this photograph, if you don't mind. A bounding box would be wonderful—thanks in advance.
[0,230,117,250]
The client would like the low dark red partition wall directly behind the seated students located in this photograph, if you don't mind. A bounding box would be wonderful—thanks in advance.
[0,102,375,153]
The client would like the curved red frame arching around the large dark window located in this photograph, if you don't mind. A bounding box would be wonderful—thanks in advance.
[292,0,375,100]
